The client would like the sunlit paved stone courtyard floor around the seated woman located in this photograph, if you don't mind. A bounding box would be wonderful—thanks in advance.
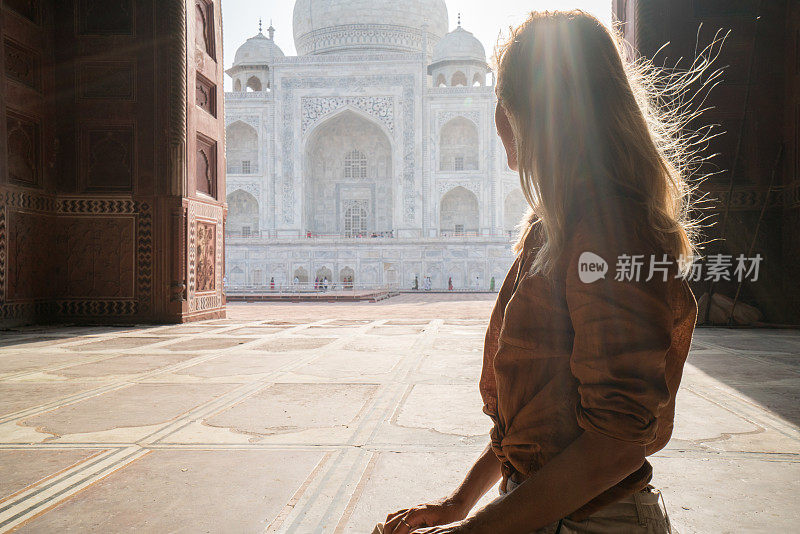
[0,295,800,534]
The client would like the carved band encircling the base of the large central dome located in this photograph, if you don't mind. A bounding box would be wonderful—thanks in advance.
[297,24,437,55]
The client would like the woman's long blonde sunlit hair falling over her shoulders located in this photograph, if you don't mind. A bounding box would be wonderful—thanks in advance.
[495,10,712,275]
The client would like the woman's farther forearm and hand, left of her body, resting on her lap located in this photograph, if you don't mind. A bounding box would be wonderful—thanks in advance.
[384,445,500,534]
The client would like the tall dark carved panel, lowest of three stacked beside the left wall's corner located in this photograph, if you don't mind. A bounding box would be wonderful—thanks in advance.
[81,125,136,191]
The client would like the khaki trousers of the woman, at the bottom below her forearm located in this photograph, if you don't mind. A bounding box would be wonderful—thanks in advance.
[500,479,678,534]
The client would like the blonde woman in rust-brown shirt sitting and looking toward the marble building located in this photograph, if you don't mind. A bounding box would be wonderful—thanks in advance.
[384,11,697,534]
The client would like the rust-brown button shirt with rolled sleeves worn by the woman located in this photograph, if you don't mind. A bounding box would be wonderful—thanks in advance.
[480,207,697,520]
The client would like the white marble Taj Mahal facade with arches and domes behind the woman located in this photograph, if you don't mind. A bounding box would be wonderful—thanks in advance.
[225,0,527,290]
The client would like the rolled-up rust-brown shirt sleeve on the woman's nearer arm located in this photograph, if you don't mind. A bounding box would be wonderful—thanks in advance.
[566,228,675,445]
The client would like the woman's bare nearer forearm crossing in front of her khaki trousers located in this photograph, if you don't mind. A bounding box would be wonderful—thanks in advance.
[450,431,645,534]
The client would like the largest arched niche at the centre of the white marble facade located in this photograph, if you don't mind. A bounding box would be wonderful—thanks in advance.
[303,110,395,236]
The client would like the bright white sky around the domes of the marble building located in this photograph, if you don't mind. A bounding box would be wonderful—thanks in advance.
[222,0,611,90]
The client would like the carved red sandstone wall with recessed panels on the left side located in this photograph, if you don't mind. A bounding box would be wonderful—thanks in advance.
[0,0,225,326]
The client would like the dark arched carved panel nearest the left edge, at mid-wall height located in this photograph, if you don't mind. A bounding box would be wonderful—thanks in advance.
[6,110,42,186]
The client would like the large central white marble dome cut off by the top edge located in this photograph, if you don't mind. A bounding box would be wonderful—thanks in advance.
[294,0,449,55]
